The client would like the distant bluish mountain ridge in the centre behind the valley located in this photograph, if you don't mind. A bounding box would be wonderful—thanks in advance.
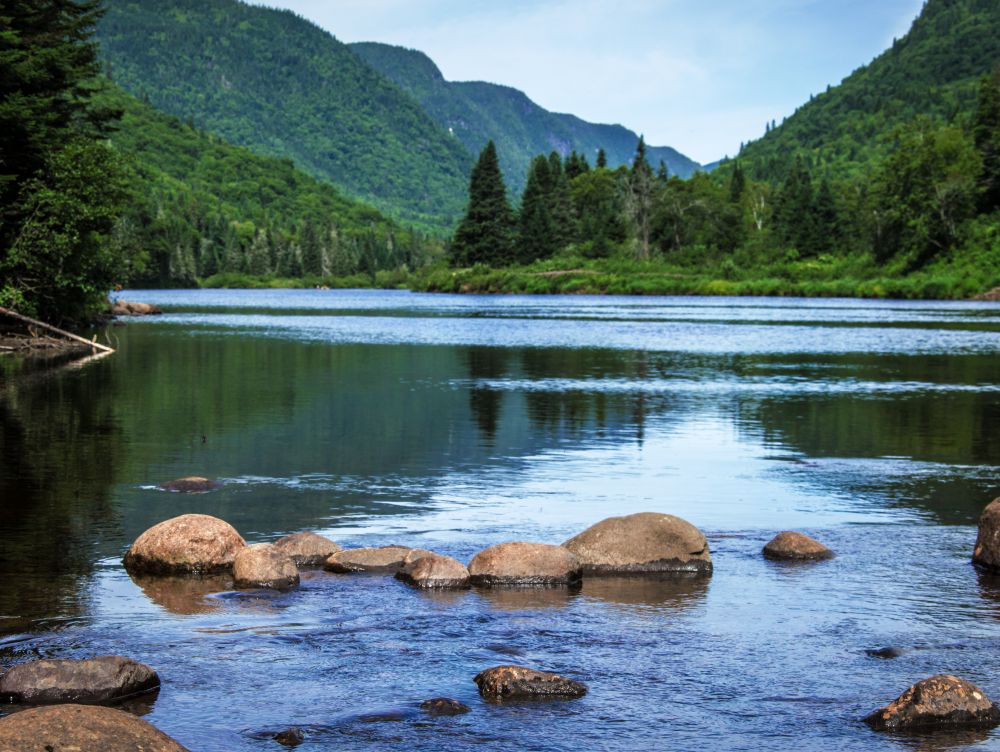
[350,42,701,193]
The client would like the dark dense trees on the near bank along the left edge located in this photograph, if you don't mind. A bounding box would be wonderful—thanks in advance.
[0,0,127,322]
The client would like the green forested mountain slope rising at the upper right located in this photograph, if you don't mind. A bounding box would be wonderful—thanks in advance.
[739,0,1000,180]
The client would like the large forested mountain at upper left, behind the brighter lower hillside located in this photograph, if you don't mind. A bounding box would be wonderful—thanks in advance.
[97,0,472,230]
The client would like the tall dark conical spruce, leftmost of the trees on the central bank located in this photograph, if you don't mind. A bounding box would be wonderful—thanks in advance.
[451,141,515,266]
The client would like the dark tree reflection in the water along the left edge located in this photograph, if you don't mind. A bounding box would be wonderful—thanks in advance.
[0,352,122,632]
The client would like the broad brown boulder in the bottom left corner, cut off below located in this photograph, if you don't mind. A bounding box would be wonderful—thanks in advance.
[0,705,188,752]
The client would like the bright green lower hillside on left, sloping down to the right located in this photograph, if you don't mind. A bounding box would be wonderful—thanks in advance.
[99,86,436,286]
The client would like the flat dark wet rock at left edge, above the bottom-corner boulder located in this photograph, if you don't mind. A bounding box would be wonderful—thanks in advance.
[0,655,160,705]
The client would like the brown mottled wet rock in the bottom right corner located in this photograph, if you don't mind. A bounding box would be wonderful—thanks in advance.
[864,674,1000,731]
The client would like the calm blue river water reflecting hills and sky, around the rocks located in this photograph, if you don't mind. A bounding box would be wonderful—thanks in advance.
[0,290,1000,752]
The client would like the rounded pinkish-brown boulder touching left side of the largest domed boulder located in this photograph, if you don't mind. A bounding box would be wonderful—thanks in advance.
[469,541,580,587]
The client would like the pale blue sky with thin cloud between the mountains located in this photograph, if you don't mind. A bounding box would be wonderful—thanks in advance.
[256,0,923,164]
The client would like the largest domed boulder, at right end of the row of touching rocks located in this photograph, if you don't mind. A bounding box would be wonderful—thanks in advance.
[563,512,712,575]
